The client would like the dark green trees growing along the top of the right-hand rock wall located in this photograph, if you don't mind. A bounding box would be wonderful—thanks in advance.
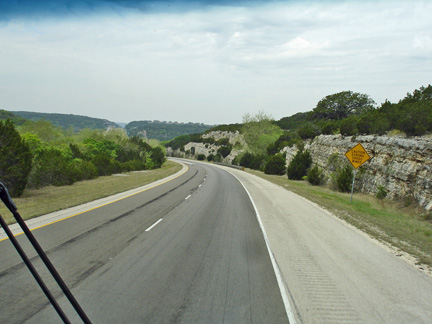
[276,85,432,139]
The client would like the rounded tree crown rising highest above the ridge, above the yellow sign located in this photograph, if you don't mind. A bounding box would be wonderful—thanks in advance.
[310,91,375,120]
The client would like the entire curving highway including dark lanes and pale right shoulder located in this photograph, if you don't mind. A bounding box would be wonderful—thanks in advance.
[0,161,432,324]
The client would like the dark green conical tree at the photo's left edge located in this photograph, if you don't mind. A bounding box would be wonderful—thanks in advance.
[0,120,32,197]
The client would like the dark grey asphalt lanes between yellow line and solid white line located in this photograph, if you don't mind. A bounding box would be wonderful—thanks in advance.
[0,164,288,324]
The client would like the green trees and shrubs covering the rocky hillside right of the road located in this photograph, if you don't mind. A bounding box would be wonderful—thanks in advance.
[165,85,432,184]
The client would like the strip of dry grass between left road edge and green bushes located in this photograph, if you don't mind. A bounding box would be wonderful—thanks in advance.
[0,161,181,224]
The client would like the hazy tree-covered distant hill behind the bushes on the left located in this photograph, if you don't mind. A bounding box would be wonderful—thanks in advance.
[13,111,120,131]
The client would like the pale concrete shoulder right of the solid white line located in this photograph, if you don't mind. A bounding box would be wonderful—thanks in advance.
[226,168,432,324]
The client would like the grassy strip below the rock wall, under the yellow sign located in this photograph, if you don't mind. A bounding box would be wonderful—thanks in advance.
[248,170,432,266]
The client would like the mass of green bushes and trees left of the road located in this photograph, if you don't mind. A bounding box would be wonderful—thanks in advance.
[0,119,166,197]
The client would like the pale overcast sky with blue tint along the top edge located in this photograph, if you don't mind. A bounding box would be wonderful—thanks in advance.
[0,0,432,124]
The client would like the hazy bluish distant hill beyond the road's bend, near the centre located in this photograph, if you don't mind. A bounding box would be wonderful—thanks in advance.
[125,120,214,141]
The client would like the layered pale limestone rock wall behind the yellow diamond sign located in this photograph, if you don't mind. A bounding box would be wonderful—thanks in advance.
[283,135,432,211]
